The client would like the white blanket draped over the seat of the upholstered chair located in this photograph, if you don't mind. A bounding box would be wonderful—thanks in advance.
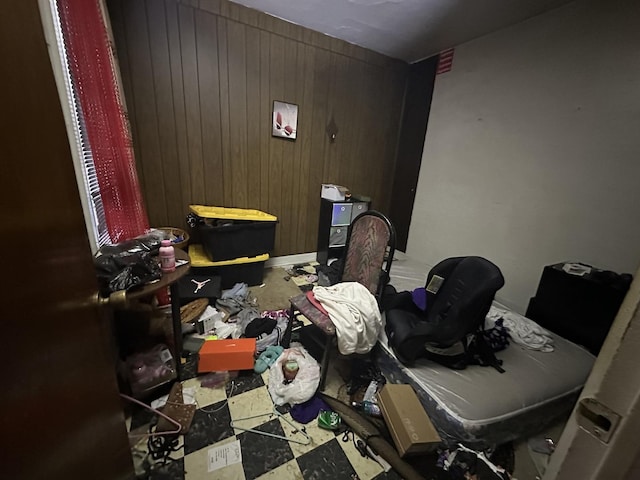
[313,282,382,355]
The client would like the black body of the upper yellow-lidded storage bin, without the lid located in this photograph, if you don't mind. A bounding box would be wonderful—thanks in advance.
[199,221,276,262]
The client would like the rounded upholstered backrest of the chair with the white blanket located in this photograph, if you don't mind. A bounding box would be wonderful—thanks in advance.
[341,210,396,302]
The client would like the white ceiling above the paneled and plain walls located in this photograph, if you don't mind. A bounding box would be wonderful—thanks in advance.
[232,0,571,63]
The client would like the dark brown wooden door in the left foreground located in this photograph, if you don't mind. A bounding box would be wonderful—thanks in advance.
[0,0,133,479]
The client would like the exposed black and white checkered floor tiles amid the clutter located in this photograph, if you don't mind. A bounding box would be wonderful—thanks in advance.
[128,362,400,480]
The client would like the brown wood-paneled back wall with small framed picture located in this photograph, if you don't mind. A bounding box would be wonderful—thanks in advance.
[108,0,408,255]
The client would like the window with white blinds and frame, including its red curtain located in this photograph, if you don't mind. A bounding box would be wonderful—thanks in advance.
[40,0,148,252]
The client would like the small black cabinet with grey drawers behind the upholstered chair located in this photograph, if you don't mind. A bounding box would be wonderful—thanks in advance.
[316,198,369,264]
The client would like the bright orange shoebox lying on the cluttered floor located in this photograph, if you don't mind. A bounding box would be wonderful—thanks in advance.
[198,338,256,373]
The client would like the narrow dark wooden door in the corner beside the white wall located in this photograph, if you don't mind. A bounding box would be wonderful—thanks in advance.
[389,56,438,252]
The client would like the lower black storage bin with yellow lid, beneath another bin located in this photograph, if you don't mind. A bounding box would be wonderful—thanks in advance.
[189,244,269,289]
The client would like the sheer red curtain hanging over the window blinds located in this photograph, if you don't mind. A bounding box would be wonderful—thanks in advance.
[58,0,149,243]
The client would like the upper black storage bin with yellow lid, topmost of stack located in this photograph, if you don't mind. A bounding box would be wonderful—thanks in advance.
[189,205,278,262]
